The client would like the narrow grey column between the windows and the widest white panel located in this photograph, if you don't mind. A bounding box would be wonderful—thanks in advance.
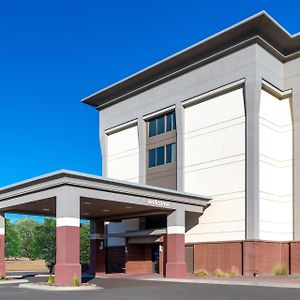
[175,103,184,192]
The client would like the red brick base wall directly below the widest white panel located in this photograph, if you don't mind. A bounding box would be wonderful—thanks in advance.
[194,242,242,274]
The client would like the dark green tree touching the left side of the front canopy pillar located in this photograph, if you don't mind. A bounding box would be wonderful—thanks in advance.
[34,218,56,273]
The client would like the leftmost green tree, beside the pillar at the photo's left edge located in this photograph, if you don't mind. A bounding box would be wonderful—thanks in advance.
[5,218,20,257]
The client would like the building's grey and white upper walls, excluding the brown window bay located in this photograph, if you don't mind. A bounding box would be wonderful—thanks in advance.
[83,12,300,243]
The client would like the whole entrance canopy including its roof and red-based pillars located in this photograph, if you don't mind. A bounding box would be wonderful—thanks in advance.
[0,170,210,285]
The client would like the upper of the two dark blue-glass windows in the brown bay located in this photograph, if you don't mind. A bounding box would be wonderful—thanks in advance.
[149,111,176,137]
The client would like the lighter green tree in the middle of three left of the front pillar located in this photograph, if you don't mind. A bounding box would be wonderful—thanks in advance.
[15,218,40,260]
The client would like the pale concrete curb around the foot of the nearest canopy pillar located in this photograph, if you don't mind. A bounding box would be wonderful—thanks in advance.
[19,283,103,292]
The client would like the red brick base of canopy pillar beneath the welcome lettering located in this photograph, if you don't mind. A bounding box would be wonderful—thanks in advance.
[166,234,186,278]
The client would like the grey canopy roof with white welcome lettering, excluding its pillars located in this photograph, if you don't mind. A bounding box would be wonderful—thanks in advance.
[0,170,210,220]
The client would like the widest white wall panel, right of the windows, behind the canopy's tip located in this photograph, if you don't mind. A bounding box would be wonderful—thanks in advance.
[184,88,245,242]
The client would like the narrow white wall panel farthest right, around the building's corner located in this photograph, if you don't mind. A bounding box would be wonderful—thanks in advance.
[259,90,293,241]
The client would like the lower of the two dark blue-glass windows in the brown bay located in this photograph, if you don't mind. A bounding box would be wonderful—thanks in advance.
[148,143,176,168]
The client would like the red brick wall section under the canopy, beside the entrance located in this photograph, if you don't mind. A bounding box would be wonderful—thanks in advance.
[125,244,152,274]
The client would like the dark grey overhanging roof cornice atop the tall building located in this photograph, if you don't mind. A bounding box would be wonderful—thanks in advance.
[82,11,300,109]
